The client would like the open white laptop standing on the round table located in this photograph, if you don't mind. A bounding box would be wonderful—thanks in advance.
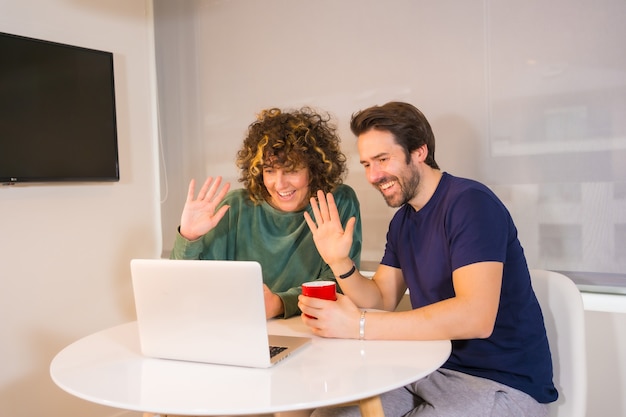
[130,259,311,368]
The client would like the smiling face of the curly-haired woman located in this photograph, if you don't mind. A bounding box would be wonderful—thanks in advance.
[263,165,311,212]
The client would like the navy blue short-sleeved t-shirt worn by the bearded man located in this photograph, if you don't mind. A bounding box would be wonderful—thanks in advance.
[381,173,558,403]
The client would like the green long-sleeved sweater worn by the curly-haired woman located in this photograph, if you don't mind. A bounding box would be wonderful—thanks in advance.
[171,184,362,318]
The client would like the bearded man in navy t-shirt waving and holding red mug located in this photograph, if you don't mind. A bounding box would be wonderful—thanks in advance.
[299,102,557,417]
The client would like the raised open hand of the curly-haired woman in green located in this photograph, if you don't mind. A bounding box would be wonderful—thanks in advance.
[180,176,230,240]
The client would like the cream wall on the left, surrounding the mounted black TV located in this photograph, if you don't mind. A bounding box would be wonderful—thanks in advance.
[0,0,161,417]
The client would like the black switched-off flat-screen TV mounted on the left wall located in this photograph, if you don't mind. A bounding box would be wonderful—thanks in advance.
[0,32,119,184]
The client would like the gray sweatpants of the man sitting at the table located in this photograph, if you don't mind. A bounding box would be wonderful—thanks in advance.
[311,368,548,417]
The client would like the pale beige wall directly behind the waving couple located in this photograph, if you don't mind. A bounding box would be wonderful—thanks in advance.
[155,0,626,276]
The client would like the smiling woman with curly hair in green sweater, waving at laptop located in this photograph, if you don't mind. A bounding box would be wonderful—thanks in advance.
[172,107,362,318]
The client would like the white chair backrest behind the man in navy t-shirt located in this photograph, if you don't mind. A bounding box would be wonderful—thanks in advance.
[530,269,587,417]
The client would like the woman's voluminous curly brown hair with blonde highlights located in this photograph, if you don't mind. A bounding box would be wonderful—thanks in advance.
[237,107,346,204]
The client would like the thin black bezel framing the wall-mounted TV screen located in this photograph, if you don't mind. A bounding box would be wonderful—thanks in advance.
[0,31,120,185]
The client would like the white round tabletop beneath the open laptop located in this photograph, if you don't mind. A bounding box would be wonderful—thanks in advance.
[50,317,451,416]
